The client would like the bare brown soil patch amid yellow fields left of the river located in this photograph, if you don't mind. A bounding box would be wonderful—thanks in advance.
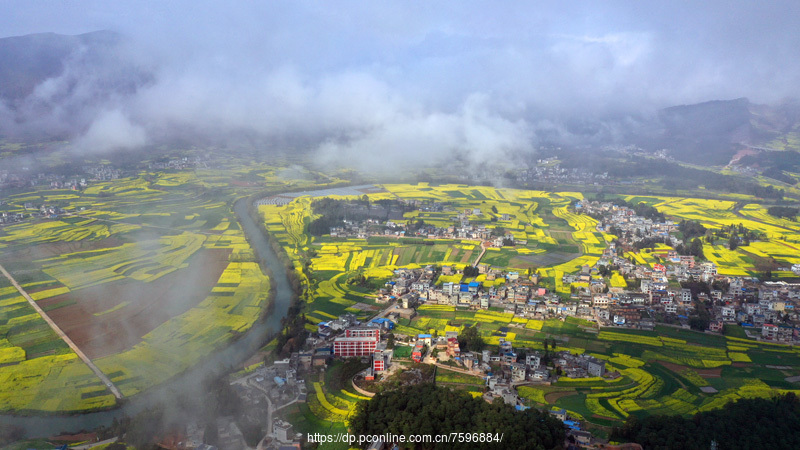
[38,249,230,359]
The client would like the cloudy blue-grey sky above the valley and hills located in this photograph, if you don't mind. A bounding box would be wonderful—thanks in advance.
[0,0,800,167]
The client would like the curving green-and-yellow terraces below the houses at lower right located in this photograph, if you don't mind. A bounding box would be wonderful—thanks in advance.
[519,327,800,425]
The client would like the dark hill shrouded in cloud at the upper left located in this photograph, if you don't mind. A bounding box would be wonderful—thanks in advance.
[0,31,153,139]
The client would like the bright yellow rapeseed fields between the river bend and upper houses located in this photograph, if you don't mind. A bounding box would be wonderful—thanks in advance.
[260,183,610,306]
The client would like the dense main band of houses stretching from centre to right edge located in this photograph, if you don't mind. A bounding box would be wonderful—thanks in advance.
[377,250,800,342]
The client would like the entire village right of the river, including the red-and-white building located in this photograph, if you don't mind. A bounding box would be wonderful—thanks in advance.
[247,198,800,444]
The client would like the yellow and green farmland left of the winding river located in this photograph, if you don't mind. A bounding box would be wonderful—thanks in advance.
[0,168,276,412]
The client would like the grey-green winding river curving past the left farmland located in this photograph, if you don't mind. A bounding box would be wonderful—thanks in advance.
[0,199,292,437]
